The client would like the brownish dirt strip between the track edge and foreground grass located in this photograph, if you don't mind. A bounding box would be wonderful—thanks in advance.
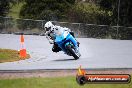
[0,69,132,79]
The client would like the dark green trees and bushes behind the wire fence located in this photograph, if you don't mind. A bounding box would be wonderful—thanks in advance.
[0,0,132,26]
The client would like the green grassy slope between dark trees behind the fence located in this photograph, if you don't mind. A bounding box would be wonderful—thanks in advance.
[8,2,24,18]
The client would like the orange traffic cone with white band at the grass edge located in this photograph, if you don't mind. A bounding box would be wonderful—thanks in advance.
[20,35,27,58]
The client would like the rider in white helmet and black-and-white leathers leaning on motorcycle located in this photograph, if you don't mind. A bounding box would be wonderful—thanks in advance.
[44,21,80,52]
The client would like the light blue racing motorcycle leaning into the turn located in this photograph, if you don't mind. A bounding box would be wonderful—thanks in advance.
[55,31,81,60]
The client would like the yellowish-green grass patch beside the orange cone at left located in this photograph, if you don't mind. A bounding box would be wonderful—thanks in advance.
[0,49,30,63]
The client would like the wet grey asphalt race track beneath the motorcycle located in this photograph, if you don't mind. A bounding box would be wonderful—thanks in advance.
[0,34,132,70]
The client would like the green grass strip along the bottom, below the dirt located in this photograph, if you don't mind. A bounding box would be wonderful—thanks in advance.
[0,77,132,88]
